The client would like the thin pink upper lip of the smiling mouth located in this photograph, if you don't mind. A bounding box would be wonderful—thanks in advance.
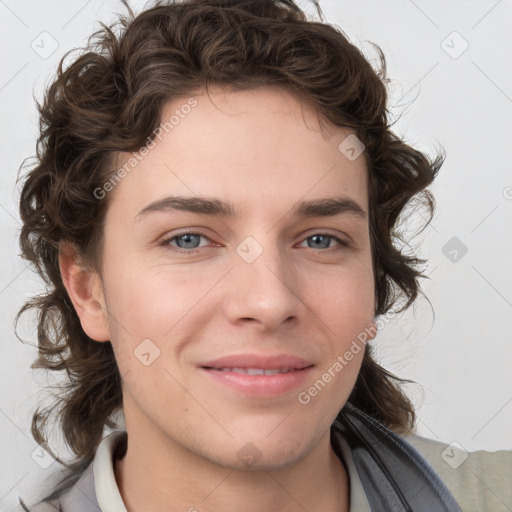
[199,354,313,370]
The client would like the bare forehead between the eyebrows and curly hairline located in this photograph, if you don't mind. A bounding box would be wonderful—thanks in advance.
[107,87,367,217]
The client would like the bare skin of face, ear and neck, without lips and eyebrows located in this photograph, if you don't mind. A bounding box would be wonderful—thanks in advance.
[60,88,375,512]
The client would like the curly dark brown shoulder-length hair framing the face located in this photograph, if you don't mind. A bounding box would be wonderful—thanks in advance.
[16,0,443,504]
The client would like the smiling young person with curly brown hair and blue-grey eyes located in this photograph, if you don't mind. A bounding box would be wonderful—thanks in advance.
[12,0,512,512]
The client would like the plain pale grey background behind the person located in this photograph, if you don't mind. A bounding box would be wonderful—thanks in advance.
[0,0,512,510]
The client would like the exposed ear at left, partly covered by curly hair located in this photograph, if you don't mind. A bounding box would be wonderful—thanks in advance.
[59,242,110,341]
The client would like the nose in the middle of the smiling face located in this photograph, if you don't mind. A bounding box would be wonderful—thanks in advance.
[223,237,305,331]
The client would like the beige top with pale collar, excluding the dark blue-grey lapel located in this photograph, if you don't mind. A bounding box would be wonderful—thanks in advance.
[13,431,512,512]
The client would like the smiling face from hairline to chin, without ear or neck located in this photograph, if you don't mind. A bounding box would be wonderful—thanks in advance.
[90,88,374,468]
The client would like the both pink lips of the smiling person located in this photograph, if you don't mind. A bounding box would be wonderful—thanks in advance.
[199,354,314,398]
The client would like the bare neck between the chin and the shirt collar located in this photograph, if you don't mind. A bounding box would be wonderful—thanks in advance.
[114,416,350,512]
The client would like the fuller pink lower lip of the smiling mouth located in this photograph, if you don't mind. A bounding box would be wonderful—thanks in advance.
[199,366,313,397]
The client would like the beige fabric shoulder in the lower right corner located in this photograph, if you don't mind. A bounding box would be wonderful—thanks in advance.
[402,434,512,512]
